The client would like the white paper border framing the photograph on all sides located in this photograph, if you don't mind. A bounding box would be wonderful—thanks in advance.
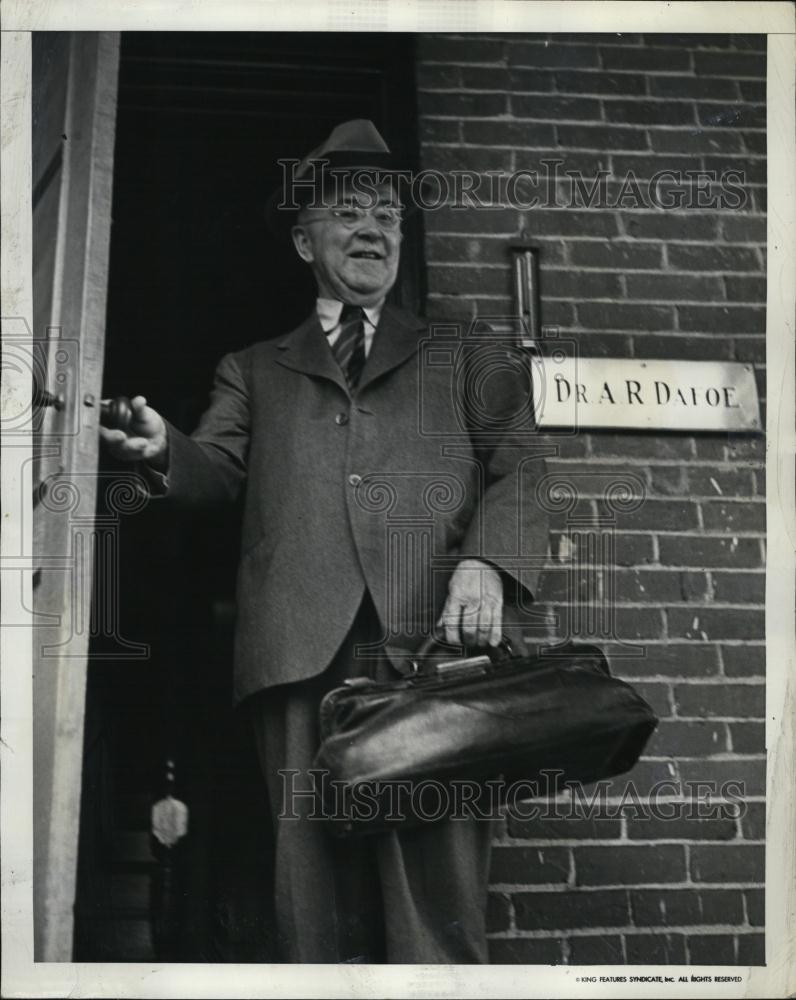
[0,0,796,998]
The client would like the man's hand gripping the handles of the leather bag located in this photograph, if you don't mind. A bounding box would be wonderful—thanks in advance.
[439,559,503,646]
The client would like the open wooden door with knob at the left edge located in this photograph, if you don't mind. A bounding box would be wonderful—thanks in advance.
[33,32,119,962]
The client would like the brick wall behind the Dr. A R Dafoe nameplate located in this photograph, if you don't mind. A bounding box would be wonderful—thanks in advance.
[417,35,766,964]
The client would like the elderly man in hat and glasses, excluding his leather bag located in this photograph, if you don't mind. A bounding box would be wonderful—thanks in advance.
[103,121,546,963]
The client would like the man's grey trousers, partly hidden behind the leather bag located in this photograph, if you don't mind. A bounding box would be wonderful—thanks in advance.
[250,595,493,963]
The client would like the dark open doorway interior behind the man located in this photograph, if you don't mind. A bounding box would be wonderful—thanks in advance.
[75,32,422,961]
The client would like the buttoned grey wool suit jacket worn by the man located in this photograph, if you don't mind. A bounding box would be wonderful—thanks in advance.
[167,305,554,702]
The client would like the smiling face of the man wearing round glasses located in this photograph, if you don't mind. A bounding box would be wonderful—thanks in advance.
[293,184,401,306]
